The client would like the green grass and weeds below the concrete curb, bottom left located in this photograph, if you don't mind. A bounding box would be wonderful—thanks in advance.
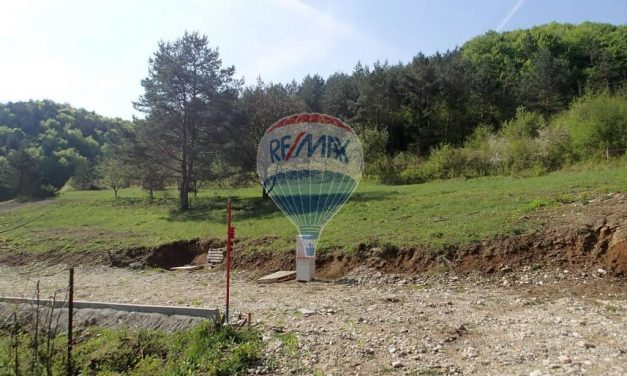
[0,322,263,376]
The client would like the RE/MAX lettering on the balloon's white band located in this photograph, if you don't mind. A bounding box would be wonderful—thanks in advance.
[269,132,350,163]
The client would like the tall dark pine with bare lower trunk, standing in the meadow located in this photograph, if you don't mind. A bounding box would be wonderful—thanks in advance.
[135,32,239,210]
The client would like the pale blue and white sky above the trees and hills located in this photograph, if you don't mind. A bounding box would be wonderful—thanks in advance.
[0,0,627,119]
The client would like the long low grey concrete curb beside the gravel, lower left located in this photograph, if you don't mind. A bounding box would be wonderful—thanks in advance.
[0,296,220,321]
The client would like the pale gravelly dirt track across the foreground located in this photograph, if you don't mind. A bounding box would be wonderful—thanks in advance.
[0,264,627,375]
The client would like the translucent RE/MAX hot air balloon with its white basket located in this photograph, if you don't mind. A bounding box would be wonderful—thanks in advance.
[257,114,364,280]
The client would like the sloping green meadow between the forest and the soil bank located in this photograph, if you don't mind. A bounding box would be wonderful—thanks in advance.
[0,166,627,252]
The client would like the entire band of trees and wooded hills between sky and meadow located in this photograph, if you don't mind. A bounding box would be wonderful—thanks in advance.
[0,23,627,209]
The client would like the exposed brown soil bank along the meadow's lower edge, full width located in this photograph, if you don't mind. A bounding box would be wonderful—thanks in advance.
[0,194,627,278]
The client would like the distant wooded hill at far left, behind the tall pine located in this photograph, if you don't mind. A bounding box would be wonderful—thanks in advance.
[0,100,126,201]
